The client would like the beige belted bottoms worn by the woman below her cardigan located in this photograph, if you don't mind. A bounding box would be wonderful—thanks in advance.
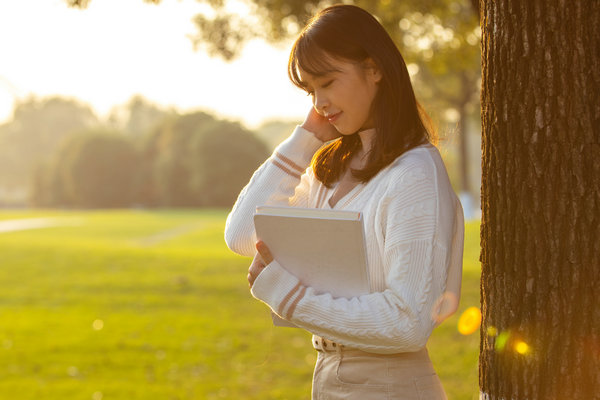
[312,336,447,400]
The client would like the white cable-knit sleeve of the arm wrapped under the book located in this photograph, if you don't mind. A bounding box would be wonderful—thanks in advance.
[252,159,454,353]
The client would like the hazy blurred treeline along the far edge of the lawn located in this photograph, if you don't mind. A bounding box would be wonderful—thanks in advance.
[0,96,270,208]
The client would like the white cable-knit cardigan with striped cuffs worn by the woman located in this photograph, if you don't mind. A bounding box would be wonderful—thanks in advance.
[225,127,464,353]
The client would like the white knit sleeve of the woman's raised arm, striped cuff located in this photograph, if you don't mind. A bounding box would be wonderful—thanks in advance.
[225,126,323,257]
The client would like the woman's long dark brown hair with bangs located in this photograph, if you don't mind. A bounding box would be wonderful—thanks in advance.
[288,4,435,186]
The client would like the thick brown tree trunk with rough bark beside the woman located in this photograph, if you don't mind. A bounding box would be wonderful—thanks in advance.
[479,0,600,400]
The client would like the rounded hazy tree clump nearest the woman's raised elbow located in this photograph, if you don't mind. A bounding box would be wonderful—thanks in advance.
[142,112,269,207]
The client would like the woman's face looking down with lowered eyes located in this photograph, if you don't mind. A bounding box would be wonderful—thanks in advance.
[299,58,381,135]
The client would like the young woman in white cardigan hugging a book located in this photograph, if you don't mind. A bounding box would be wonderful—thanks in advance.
[225,5,463,400]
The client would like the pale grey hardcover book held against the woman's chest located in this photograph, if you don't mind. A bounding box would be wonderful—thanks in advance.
[254,206,370,326]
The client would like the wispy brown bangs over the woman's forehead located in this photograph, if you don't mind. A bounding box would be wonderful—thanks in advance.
[288,35,339,89]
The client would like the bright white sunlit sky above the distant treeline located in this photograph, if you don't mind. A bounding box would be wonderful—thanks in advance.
[0,0,310,128]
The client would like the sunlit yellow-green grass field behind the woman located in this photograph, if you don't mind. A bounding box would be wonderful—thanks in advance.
[0,210,479,400]
